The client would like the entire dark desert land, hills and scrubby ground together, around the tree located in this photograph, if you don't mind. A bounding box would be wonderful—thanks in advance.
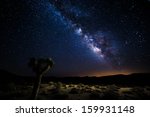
[0,70,150,100]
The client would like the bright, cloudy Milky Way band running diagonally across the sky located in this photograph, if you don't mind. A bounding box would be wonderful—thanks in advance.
[50,0,120,66]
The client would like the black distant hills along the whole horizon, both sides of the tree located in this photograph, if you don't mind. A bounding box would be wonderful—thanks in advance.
[0,70,150,85]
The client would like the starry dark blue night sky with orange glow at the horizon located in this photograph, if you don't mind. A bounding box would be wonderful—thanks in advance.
[0,0,150,76]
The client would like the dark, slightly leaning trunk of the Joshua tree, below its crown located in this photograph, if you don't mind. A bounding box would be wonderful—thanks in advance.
[31,75,42,100]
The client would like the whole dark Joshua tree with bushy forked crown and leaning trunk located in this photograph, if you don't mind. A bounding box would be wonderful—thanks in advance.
[28,58,54,99]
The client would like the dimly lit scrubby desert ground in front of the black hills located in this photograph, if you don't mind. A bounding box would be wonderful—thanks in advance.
[0,82,150,100]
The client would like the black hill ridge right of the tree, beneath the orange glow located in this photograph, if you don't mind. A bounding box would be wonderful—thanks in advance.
[44,73,150,85]
